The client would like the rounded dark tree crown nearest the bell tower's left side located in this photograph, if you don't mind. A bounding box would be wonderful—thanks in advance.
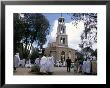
[24,13,49,48]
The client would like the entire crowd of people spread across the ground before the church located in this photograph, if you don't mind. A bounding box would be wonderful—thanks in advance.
[13,53,96,74]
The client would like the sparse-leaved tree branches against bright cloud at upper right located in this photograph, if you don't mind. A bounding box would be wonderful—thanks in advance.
[71,13,97,48]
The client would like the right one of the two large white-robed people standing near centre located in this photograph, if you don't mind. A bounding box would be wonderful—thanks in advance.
[47,56,54,74]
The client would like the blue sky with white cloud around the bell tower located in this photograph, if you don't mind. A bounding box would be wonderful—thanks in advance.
[43,13,84,50]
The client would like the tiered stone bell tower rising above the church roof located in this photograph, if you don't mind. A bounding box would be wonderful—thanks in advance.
[56,14,68,47]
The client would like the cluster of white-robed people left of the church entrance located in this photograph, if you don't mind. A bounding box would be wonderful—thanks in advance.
[13,53,54,74]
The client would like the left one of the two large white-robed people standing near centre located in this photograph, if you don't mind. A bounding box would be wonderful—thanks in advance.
[40,55,47,73]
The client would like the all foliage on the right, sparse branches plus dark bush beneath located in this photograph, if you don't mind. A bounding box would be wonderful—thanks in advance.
[70,13,97,59]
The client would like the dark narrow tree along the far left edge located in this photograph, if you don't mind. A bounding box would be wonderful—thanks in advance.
[13,13,25,53]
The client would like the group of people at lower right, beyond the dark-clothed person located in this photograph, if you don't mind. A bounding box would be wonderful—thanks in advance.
[74,59,97,75]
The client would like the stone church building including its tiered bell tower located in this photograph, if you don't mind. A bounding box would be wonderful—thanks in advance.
[45,16,76,62]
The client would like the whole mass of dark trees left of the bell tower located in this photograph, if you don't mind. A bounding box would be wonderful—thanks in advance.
[14,13,49,58]
